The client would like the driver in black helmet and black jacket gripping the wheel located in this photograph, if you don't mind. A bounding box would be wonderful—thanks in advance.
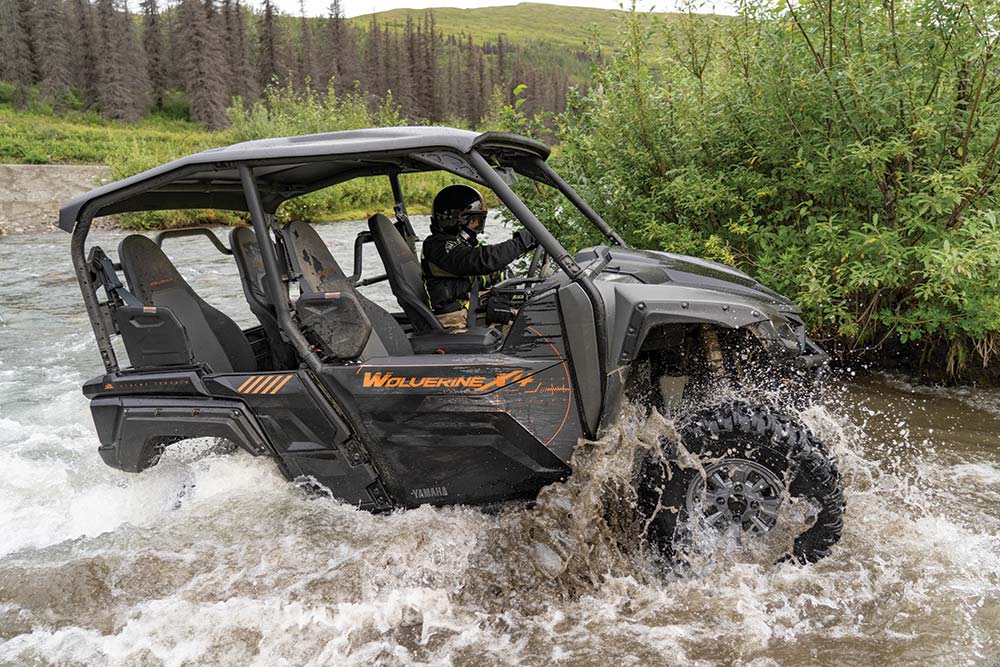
[420,184,538,331]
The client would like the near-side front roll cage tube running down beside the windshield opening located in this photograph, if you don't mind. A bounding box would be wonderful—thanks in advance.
[468,150,608,408]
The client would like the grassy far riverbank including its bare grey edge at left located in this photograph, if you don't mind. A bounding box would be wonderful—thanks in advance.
[0,100,446,234]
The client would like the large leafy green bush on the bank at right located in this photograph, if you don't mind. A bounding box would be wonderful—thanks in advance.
[532,0,1000,372]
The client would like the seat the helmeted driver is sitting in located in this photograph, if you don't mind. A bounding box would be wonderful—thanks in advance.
[368,213,503,354]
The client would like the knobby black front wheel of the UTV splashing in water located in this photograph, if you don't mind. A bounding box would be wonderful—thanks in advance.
[637,403,844,562]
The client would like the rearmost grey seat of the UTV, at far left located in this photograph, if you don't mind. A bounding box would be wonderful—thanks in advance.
[118,234,257,373]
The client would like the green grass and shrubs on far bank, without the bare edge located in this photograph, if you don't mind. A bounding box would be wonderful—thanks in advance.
[0,82,472,229]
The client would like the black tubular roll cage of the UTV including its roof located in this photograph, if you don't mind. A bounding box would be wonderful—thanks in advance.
[58,128,626,394]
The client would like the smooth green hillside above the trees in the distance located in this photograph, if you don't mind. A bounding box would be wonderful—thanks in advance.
[351,2,672,50]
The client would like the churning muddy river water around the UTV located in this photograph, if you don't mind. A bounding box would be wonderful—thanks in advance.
[0,224,1000,667]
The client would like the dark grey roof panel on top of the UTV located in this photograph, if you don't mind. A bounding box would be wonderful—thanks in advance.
[58,127,549,232]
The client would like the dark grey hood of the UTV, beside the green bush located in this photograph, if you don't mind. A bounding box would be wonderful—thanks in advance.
[576,248,798,312]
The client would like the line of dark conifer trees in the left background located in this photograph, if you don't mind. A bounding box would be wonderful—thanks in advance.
[0,0,583,129]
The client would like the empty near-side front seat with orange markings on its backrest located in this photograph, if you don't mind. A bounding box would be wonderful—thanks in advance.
[282,221,413,359]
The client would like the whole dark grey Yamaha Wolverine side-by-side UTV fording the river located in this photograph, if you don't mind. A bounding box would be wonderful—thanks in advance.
[58,127,843,561]
